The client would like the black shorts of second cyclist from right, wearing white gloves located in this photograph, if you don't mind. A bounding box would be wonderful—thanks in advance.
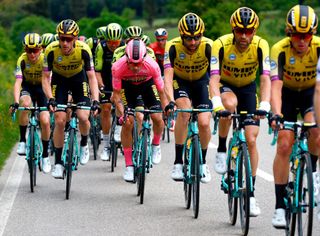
[220,81,260,126]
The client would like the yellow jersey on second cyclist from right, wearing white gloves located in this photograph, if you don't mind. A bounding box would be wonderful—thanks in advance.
[211,34,270,87]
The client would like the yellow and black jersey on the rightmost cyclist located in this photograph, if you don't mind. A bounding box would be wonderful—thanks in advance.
[271,36,320,91]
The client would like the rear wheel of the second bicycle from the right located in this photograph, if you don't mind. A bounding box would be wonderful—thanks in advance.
[227,142,238,225]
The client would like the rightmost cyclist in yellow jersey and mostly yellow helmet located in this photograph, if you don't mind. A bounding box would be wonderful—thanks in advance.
[271,5,320,228]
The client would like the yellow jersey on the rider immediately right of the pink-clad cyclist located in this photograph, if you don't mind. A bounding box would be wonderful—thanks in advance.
[163,37,213,81]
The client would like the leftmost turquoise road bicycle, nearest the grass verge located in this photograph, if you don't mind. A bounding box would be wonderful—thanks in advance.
[12,107,47,192]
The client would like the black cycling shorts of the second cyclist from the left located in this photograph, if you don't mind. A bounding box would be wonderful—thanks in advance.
[51,70,90,106]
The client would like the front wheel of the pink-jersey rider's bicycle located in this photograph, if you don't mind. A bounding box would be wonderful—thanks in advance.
[139,129,148,204]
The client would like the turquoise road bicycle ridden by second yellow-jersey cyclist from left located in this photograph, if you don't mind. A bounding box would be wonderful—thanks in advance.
[57,104,91,199]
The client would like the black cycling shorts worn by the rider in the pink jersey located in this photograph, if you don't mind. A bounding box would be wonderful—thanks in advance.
[121,79,162,110]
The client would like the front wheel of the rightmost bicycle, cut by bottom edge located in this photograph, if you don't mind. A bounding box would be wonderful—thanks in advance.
[296,153,313,236]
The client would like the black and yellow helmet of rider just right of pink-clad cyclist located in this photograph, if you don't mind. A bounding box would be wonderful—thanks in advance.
[178,12,204,36]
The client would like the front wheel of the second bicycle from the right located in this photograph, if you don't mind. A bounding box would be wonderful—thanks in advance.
[238,143,250,235]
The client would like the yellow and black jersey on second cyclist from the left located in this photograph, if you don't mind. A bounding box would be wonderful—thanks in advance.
[43,40,93,78]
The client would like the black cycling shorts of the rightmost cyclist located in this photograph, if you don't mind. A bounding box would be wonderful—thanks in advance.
[281,87,314,122]
